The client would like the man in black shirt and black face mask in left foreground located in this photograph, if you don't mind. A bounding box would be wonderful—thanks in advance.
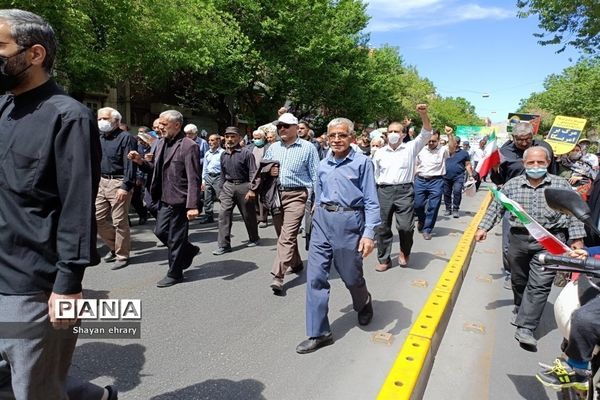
[0,9,116,400]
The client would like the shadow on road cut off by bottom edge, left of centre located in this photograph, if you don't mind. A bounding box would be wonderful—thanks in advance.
[150,379,266,400]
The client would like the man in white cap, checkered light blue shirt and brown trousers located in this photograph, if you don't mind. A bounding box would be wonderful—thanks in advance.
[264,113,319,294]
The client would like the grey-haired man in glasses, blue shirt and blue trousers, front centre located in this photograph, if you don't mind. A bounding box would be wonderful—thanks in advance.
[296,118,381,354]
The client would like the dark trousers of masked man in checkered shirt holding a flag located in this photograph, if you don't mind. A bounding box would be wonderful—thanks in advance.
[506,230,565,330]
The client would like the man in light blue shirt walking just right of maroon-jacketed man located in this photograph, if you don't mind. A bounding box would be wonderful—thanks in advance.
[200,134,225,224]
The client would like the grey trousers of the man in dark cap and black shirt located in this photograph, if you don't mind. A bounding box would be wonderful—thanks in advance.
[218,182,259,248]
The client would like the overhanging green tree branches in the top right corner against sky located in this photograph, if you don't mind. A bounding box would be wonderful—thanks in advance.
[517,0,600,53]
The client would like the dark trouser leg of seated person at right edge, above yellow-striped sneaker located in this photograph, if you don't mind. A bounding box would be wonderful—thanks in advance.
[565,297,600,361]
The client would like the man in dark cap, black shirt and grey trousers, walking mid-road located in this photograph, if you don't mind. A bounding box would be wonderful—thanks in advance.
[213,126,259,256]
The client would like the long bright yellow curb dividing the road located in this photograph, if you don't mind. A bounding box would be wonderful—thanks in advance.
[377,192,492,400]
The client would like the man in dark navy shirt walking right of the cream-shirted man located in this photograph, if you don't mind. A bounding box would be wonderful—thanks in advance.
[444,136,473,218]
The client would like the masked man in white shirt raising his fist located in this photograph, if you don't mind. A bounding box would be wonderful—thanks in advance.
[373,104,432,272]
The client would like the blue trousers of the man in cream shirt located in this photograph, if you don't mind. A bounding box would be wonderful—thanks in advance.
[415,176,444,233]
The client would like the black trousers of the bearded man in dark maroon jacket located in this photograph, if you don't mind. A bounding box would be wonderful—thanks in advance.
[154,201,194,279]
